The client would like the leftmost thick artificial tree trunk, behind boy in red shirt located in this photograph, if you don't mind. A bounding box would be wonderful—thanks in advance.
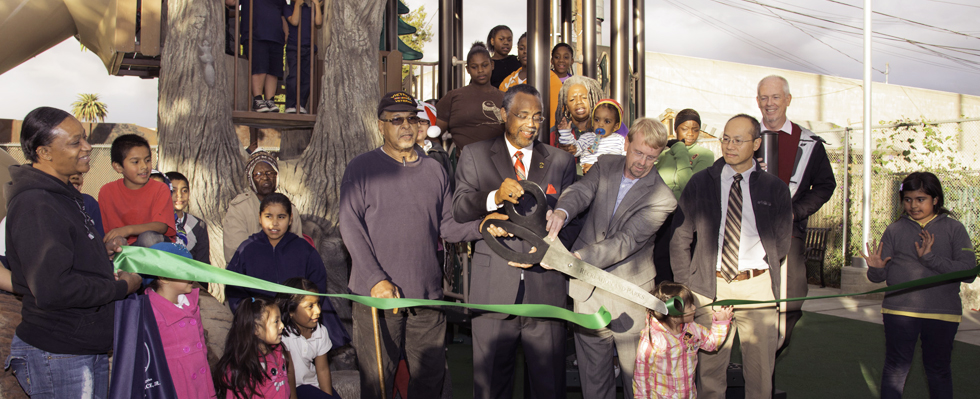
[157,0,245,280]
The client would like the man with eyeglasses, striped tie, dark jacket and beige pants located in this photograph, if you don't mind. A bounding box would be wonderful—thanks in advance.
[670,114,793,399]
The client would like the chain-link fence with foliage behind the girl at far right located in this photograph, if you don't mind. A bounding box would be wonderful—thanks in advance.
[808,118,980,290]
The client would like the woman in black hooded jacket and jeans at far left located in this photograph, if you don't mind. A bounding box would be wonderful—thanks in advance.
[5,107,140,399]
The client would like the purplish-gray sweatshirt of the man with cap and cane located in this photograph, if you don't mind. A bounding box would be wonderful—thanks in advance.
[339,146,482,299]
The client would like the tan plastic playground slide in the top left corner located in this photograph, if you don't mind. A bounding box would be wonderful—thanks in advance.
[0,0,122,74]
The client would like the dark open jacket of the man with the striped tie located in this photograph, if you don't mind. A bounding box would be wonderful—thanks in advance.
[670,158,793,298]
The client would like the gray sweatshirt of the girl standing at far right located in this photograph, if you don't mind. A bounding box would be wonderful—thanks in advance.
[868,213,977,315]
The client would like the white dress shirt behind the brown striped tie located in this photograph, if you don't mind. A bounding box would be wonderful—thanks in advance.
[715,160,769,273]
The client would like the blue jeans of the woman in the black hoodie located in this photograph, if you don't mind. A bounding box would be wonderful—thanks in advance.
[4,335,109,399]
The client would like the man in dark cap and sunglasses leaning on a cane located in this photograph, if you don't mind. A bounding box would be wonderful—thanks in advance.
[339,91,506,399]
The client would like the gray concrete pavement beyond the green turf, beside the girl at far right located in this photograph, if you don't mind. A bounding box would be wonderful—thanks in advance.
[803,285,980,346]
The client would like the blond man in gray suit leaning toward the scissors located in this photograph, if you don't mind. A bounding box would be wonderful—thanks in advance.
[548,118,677,399]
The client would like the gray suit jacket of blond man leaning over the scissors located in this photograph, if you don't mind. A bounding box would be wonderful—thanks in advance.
[556,155,677,327]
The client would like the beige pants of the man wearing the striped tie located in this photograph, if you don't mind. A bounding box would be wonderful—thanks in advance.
[694,273,779,399]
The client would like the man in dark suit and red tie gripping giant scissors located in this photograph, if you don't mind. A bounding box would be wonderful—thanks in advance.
[453,85,575,399]
